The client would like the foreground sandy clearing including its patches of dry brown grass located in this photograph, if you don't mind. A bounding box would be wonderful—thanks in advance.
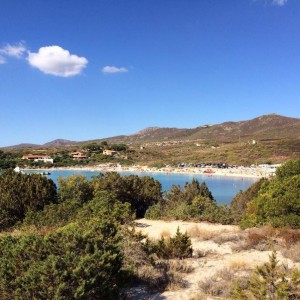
[130,220,300,300]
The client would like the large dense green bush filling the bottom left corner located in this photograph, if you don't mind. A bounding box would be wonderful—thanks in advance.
[0,219,122,300]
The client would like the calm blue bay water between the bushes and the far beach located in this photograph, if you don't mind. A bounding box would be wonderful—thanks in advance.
[26,170,257,204]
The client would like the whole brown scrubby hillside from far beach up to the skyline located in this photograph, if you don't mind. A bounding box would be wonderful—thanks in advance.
[4,114,300,165]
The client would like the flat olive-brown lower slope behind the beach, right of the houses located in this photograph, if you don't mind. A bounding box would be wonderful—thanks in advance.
[131,139,300,166]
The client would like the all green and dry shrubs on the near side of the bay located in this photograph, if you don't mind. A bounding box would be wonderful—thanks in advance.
[0,159,300,300]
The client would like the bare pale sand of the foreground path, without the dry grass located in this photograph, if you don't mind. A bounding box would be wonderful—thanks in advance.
[136,219,298,300]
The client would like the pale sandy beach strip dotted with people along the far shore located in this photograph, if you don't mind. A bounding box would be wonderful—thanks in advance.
[22,164,274,179]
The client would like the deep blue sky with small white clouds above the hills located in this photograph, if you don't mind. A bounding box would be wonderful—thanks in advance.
[0,0,300,147]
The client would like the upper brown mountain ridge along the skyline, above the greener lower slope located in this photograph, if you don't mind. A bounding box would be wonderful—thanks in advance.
[2,114,300,148]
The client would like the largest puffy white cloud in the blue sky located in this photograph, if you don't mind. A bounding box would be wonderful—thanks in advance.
[27,46,88,77]
